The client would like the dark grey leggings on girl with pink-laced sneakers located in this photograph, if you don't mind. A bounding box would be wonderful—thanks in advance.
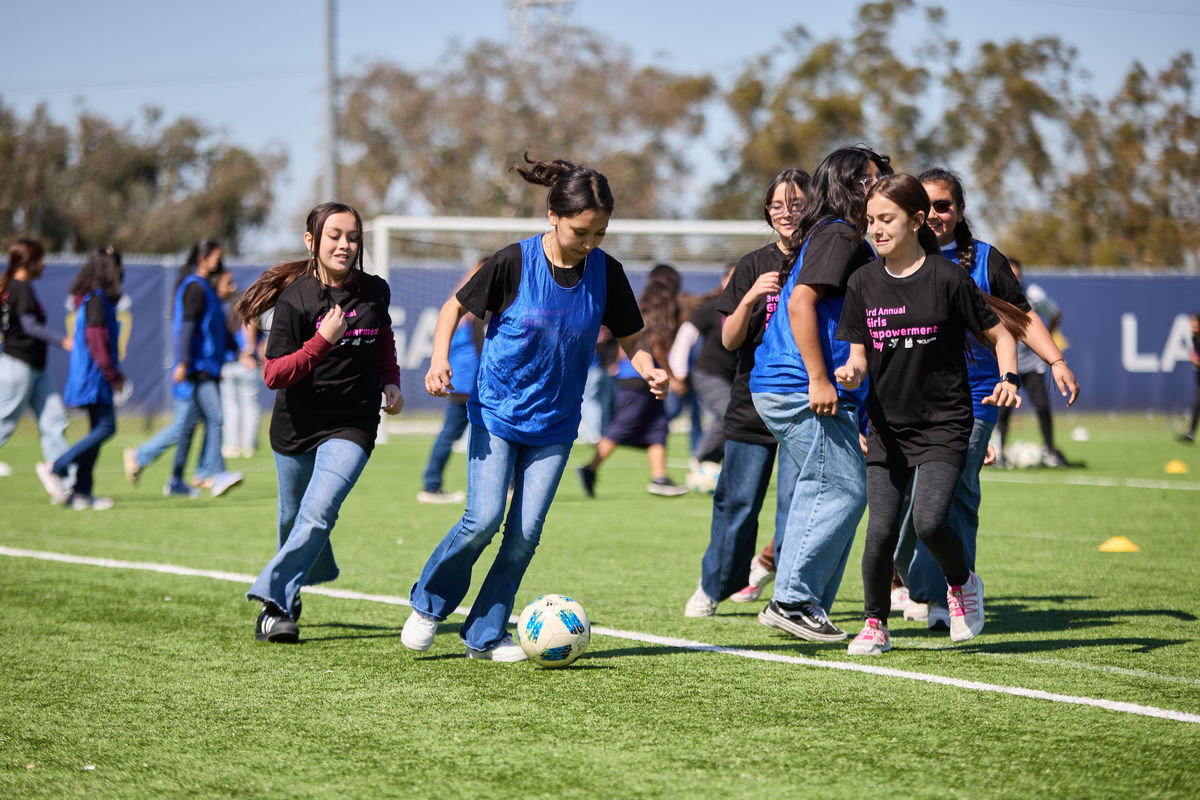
[863,461,968,622]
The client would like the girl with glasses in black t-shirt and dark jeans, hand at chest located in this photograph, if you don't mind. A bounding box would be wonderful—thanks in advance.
[683,169,811,616]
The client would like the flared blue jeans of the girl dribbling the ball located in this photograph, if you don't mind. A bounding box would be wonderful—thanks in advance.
[409,425,571,650]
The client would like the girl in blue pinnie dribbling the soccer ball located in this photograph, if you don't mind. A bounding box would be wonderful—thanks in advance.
[401,156,667,662]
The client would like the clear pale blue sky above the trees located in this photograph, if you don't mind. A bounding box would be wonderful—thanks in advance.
[0,0,1200,249]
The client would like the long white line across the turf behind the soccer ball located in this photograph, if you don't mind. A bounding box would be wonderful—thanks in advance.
[0,546,1200,723]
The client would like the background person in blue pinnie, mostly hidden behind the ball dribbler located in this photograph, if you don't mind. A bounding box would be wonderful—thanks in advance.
[416,259,486,504]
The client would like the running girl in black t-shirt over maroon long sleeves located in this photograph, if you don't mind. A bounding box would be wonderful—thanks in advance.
[236,203,404,642]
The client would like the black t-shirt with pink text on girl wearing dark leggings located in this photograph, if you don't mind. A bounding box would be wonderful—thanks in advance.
[838,254,1000,468]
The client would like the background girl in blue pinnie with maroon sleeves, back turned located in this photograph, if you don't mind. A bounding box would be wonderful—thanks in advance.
[37,247,125,510]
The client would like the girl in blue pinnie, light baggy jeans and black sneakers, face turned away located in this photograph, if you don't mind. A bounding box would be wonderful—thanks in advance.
[750,146,890,642]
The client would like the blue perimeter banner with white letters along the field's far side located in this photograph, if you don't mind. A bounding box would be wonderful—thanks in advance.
[9,263,1200,414]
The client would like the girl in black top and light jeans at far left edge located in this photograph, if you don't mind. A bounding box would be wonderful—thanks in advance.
[0,239,71,479]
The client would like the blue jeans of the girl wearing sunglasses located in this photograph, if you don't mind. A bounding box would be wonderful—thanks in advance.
[895,419,996,603]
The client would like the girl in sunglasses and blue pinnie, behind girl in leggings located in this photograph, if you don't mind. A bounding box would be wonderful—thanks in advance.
[896,168,1079,630]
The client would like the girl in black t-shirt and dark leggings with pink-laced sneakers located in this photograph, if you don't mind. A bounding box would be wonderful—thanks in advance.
[834,175,1025,655]
